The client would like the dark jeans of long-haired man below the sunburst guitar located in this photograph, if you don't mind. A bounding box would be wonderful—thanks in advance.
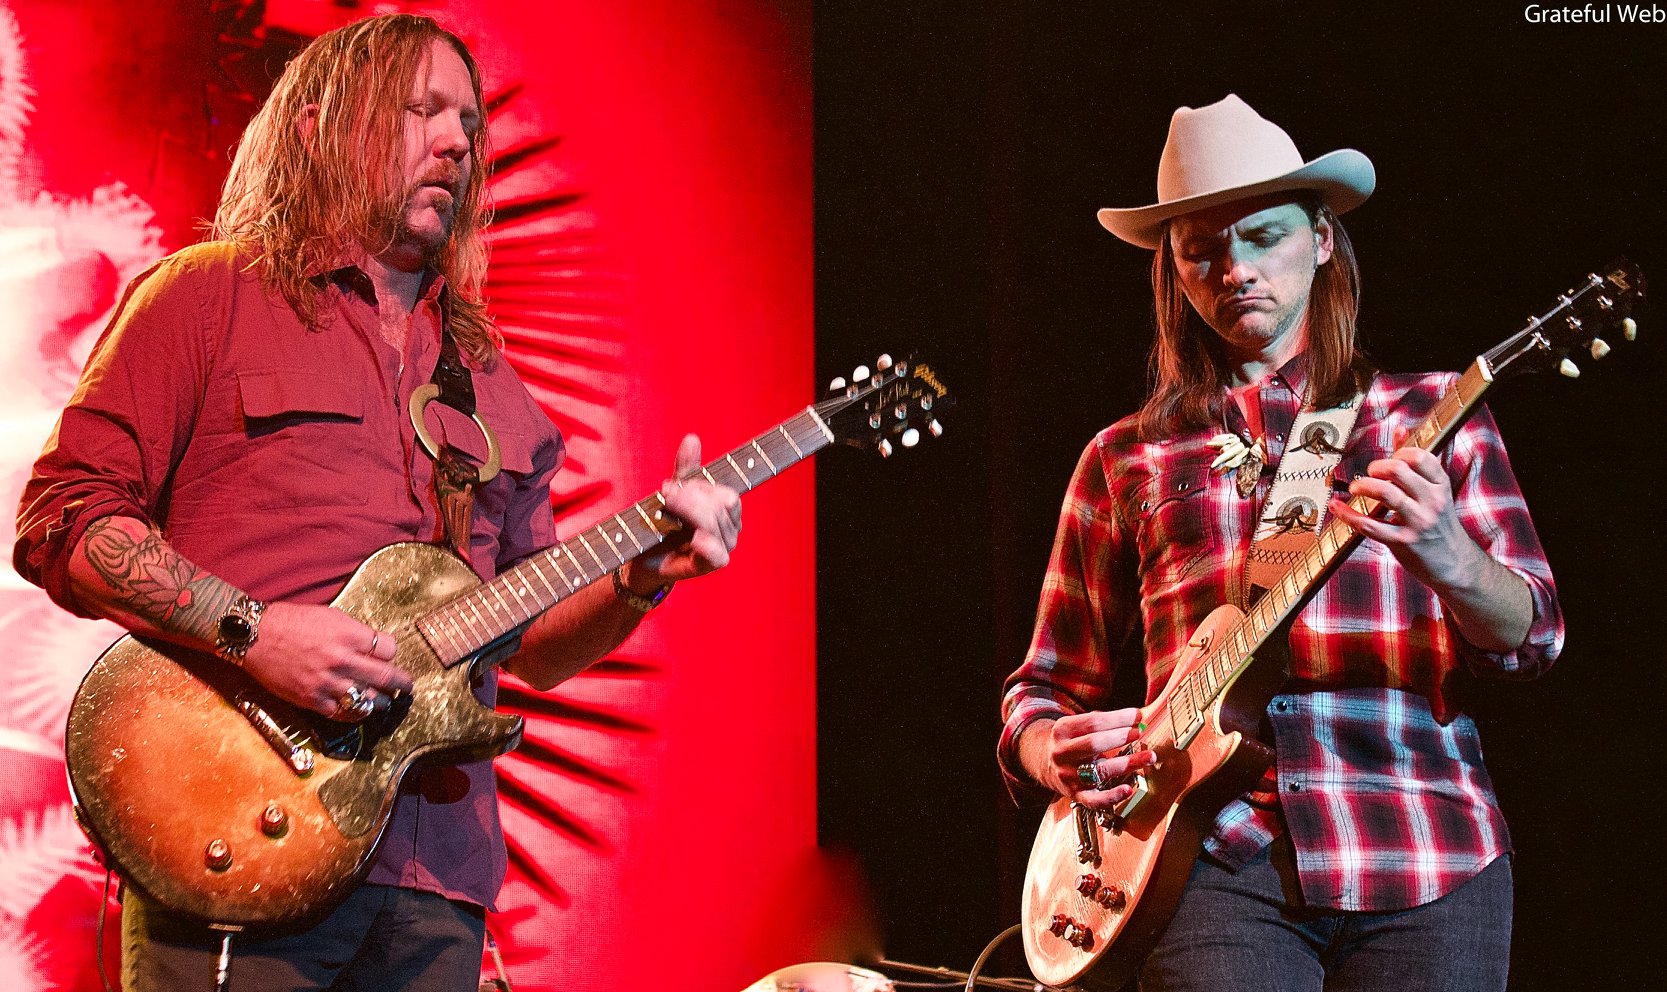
[122,885,487,992]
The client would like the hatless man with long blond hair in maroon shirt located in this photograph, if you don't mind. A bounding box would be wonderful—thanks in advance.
[15,15,740,992]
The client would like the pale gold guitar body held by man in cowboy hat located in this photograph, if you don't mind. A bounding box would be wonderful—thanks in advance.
[1022,605,1285,992]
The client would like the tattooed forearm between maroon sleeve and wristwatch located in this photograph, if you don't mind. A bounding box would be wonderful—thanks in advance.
[85,517,237,642]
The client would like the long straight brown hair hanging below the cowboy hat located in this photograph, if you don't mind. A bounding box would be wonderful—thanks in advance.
[1139,195,1372,440]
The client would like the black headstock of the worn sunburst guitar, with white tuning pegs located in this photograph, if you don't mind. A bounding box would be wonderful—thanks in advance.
[815,355,954,457]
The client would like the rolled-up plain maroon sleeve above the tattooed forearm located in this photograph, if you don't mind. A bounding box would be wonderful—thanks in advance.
[12,253,223,617]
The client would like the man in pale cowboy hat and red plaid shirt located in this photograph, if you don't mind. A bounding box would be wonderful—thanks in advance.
[1000,95,1562,990]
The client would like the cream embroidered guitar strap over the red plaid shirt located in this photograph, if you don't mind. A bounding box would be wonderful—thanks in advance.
[1245,393,1364,599]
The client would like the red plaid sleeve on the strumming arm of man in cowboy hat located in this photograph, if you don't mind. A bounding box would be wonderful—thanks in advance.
[997,442,1139,800]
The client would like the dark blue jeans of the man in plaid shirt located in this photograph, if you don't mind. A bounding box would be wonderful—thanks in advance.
[1140,839,1512,992]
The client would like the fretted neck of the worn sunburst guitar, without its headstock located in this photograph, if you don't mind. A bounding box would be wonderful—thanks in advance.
[417,407,834,665]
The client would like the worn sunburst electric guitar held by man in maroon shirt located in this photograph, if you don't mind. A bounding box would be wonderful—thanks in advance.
[65,357,949,929]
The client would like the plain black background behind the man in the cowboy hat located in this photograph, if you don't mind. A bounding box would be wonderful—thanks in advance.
[815,0,1667,990]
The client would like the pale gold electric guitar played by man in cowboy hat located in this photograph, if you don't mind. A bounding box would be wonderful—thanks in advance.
[1022,263,1644,992]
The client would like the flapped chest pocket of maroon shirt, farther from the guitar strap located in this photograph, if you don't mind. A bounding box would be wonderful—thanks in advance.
[237,368,373,509]
